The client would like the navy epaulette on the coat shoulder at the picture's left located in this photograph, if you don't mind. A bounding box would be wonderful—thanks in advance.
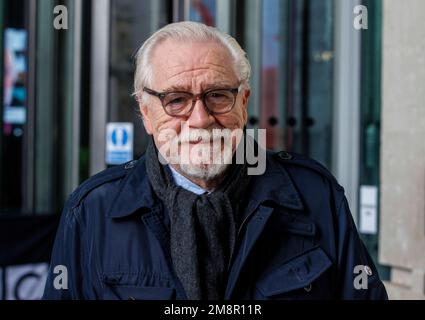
[68,160,138,207]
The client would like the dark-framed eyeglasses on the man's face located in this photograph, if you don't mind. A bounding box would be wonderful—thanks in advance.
[143,86,241,117]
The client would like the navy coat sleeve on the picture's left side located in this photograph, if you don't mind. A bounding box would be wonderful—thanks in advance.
[43,205,83,300]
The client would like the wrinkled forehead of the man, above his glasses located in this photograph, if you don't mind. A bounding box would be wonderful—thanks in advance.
[151,40,238,90]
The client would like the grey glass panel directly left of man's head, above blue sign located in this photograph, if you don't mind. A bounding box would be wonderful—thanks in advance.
[109,0,170,159]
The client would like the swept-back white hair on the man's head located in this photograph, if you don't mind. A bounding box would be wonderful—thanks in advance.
[133,21,251,99]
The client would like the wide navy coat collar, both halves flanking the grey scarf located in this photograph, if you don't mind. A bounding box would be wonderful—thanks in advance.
[107,152,304,218]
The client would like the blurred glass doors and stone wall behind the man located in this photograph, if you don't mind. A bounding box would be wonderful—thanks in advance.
[0,0,425,299]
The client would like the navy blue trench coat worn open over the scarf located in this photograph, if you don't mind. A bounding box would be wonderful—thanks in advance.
[43,151,387,300]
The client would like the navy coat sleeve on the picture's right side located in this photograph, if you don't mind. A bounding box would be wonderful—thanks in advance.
[337,196,388,300]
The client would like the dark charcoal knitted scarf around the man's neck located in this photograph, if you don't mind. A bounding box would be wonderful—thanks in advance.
[146,139,249,300]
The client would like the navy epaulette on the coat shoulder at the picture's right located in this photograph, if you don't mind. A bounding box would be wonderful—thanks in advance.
[273,151,343,190]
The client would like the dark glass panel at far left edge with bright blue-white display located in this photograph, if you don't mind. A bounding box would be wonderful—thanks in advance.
[0,0,28,213]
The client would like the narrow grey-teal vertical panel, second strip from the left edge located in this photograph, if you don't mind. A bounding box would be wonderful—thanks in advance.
[34,0,56,213]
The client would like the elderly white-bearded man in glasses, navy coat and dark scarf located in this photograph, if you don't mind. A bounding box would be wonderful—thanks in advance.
[44,22,387,300]
